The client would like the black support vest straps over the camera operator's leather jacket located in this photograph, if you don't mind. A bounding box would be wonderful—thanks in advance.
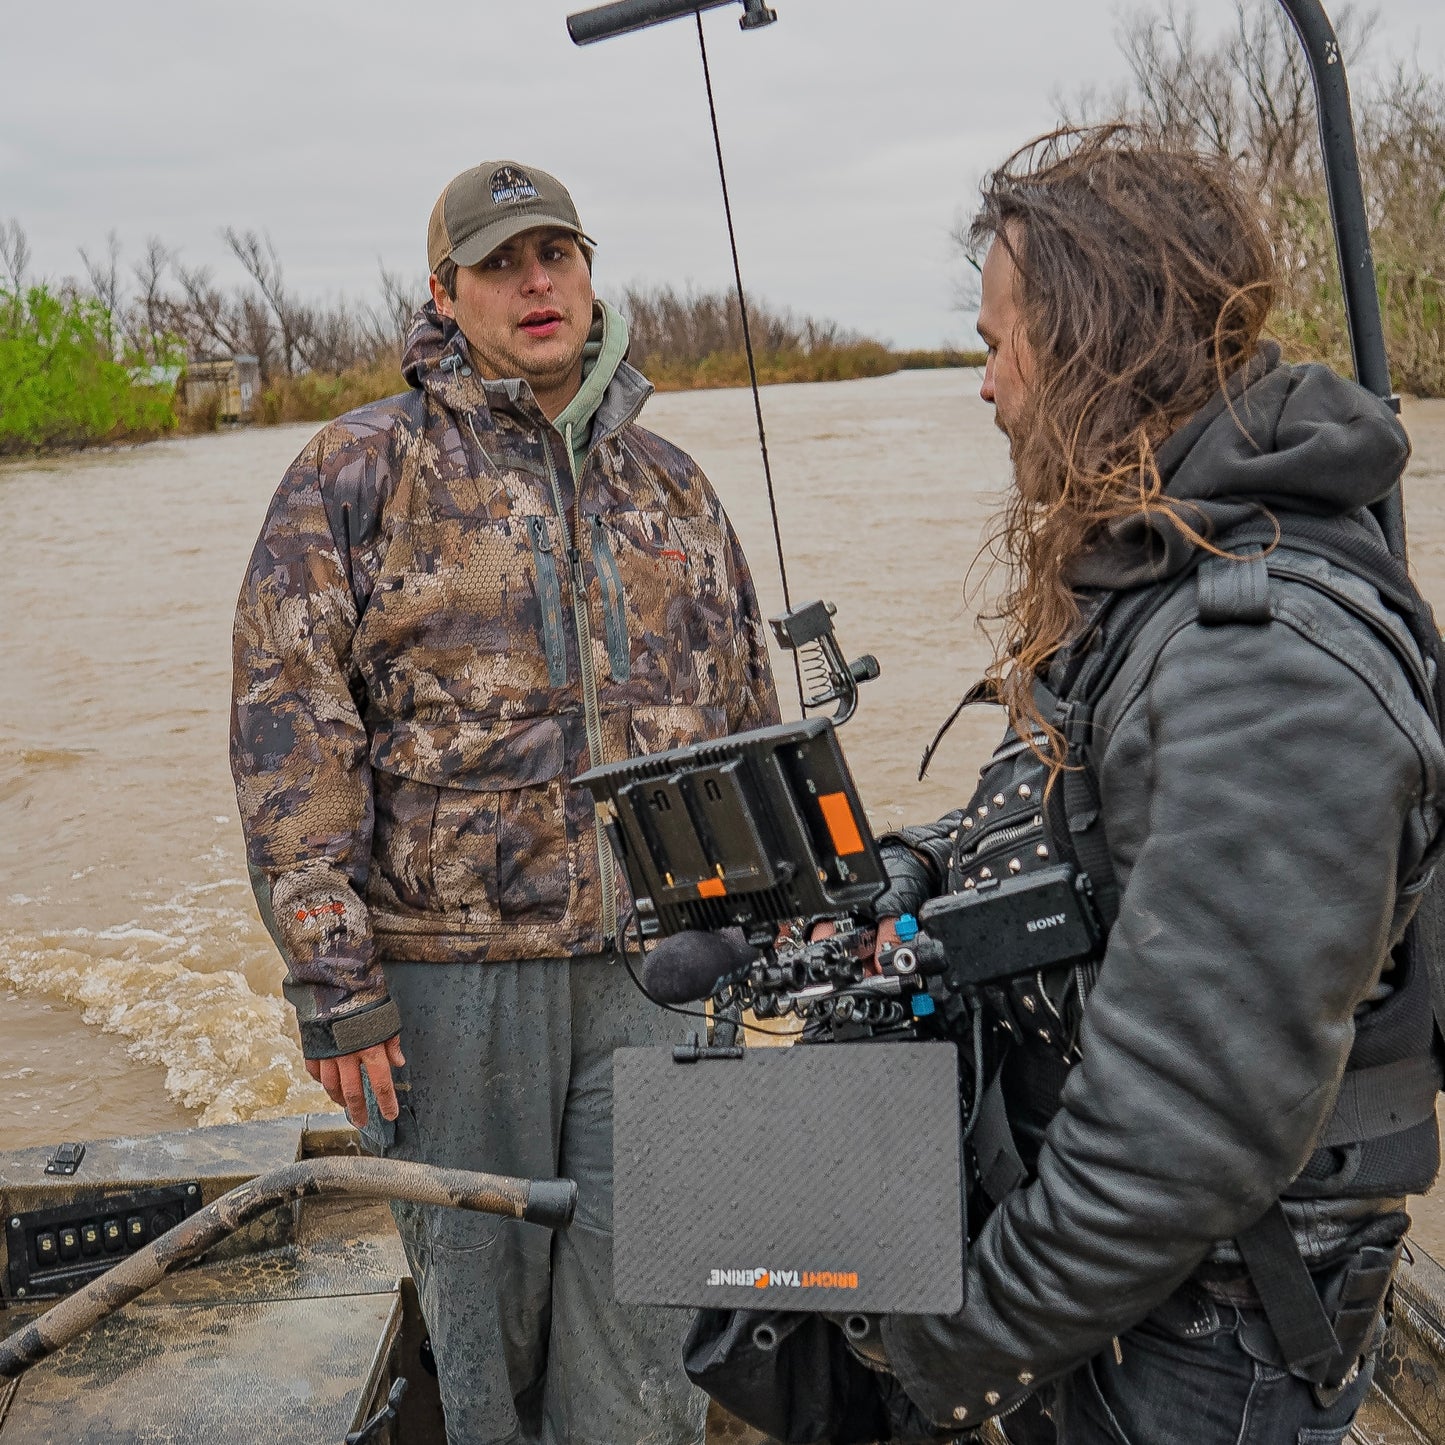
[1036,514,1445,1384]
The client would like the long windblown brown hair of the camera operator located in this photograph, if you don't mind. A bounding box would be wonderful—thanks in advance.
[968,126,1276,769]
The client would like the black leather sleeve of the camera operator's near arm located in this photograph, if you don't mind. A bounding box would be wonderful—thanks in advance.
[883,590,1439,1425]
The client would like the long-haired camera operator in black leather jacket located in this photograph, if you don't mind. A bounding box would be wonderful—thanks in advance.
[689,129,1445,1445]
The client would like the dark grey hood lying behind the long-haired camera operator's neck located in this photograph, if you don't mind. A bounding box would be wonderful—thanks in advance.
[1069,342,1410,591]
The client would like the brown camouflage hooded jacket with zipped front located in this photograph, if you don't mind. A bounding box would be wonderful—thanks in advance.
[231,305,777,1058]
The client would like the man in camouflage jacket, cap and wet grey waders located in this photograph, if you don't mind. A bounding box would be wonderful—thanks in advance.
[231,162,777,1445]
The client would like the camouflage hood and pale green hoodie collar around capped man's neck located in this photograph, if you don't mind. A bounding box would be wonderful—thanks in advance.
[402,301,652,470]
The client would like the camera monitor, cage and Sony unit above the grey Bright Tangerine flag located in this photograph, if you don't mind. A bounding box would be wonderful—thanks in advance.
[577,718,1101,1042]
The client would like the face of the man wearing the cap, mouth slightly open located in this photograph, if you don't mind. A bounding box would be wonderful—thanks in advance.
[431,227,594,410]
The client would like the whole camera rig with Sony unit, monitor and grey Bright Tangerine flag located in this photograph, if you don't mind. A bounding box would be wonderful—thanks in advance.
[577,603,1098,1316]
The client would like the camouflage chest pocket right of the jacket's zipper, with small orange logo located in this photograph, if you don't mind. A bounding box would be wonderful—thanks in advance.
[588,509,736,704]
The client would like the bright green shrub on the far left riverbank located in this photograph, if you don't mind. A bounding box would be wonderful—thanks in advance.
[0,285,175,454]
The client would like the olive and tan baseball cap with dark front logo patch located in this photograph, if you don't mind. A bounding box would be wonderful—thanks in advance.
[426,160,597,270]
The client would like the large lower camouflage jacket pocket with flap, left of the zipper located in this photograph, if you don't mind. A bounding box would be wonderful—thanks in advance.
[371,717,575,928]
